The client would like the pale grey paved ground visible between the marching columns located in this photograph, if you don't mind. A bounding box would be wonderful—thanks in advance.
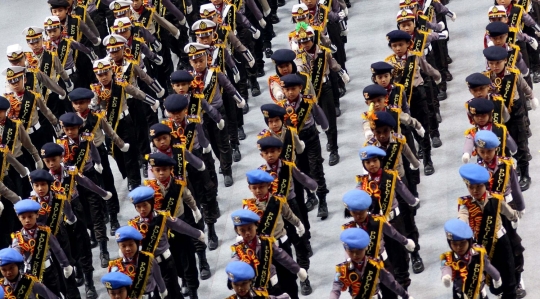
[0,0,540,299]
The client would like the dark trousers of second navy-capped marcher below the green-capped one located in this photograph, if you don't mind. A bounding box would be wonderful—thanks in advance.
[296,125,329,198]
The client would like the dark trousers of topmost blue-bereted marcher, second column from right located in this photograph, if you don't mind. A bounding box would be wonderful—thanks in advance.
[384,214,411,289]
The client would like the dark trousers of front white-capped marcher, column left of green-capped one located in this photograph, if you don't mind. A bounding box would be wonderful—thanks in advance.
[203,106,232,175]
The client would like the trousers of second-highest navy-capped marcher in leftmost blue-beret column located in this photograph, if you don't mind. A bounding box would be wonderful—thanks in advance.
[77,168,109,241]
